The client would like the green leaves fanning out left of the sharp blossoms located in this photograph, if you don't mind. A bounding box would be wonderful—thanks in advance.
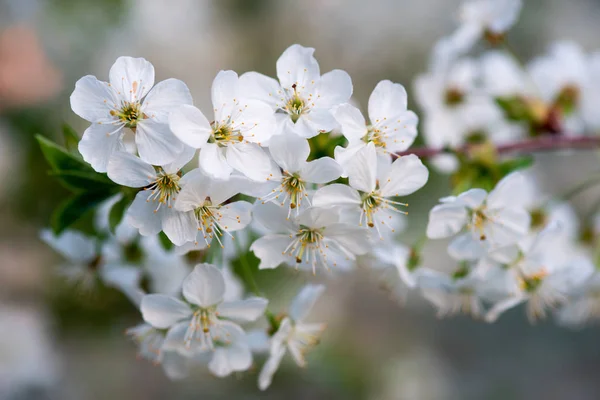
[36,131,122,235]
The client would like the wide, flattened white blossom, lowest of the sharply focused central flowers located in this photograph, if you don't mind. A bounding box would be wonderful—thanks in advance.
[250,203,370,274]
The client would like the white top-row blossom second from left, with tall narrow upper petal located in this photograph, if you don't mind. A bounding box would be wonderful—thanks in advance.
[169,71,274,181]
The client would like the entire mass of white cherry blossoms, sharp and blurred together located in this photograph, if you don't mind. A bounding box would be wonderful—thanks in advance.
[41,0,600,389]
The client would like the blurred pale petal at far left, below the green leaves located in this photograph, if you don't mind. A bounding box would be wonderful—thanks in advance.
[40,229,97,263]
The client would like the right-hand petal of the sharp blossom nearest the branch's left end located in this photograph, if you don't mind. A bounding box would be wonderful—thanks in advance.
[380,154,429,197]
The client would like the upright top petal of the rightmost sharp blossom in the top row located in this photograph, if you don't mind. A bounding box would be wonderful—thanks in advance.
[369,80,407,124]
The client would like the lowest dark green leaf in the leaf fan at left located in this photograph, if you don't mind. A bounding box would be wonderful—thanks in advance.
[50,191,113,235]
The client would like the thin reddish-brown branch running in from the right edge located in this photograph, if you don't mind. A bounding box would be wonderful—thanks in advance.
[396,136,600,158]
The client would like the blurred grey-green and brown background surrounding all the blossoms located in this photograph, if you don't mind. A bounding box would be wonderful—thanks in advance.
[0,0,600,400]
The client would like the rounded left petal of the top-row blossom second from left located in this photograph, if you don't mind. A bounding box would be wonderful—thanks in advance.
[169,105,213,149]
